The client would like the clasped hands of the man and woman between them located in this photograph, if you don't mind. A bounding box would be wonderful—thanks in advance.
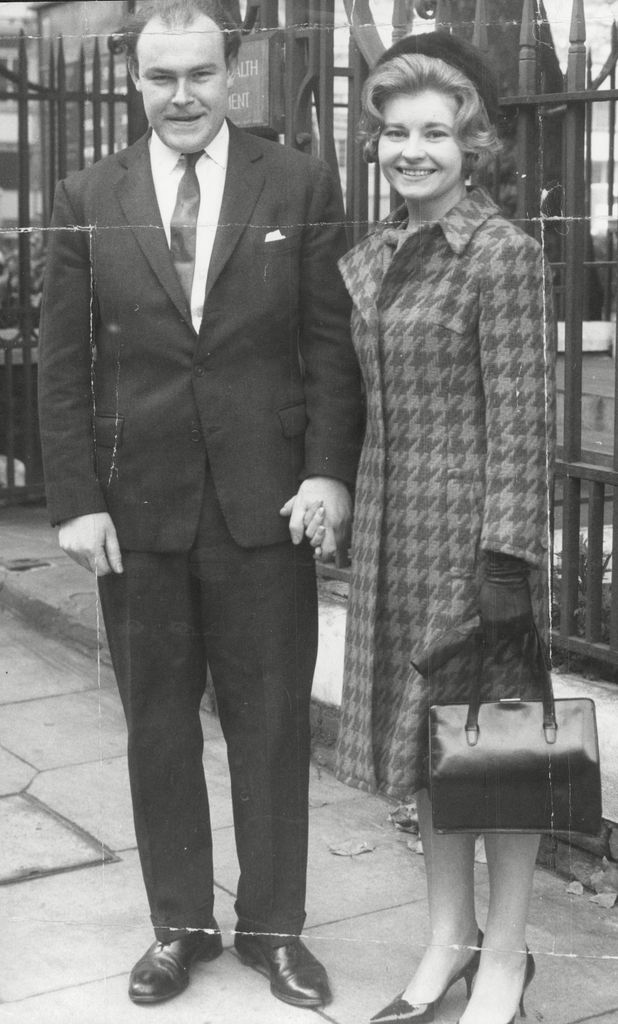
[280,476,352,565]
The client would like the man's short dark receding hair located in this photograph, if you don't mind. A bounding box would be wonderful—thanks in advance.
[117,0,241,72]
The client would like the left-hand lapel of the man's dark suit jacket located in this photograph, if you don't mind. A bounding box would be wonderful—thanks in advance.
[118,136,191,325]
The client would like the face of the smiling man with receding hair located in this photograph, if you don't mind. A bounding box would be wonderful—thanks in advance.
[131,14,235,153]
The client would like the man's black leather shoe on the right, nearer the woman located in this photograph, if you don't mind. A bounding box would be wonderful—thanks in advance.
[234,932,333,1007]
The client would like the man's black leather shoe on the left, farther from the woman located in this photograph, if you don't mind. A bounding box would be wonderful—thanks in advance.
[129,921,223,1002]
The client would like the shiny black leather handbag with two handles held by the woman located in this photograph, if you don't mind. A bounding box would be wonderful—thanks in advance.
[430,644,602,836]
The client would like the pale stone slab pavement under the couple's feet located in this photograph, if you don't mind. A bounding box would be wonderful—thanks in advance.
[0,508,618,1024]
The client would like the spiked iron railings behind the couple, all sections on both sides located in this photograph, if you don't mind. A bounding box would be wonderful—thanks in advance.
[0,0,618,667]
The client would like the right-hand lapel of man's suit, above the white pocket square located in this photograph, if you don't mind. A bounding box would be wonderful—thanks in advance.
[206,124,264,300]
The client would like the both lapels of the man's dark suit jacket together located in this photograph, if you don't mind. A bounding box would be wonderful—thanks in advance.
[117,122,264,326]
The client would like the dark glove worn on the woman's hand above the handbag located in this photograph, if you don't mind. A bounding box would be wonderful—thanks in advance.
[479,551,534,647]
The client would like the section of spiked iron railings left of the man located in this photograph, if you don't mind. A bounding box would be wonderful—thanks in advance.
[0,19,145,502]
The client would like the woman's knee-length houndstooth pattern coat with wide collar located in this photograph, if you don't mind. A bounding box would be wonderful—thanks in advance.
[337,188,555,799]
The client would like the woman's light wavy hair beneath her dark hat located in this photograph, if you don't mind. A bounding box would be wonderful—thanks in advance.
[359,53,500,173]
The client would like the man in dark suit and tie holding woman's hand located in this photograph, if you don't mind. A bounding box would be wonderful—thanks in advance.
[39,0,360,1007]
